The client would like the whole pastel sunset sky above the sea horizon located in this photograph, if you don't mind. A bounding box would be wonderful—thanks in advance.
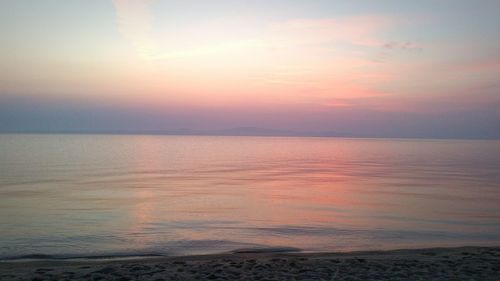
[0,0,500,138]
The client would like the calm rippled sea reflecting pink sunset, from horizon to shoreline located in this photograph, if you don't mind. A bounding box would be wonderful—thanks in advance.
[0,135,500,257]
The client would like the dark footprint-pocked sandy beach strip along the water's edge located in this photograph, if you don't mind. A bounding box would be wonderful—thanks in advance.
[0,247,500,281]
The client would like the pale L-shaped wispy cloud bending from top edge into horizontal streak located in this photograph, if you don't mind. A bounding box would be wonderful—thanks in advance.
[129,13,393,60]
